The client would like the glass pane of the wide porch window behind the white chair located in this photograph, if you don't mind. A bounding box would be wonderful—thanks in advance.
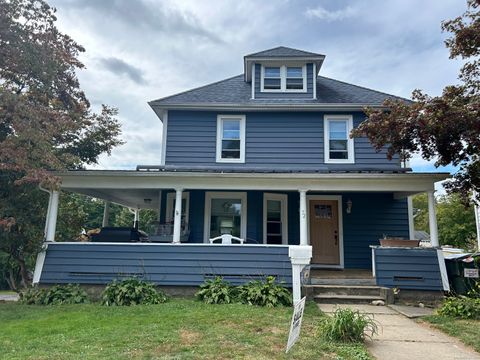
[210,199,242,238]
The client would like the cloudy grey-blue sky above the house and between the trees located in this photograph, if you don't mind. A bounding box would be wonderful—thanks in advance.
[49,0,466,175]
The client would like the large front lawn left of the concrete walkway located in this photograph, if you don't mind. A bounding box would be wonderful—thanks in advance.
[0,299,370,360]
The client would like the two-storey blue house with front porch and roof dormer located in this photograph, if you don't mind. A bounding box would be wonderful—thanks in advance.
[35,47,448,300]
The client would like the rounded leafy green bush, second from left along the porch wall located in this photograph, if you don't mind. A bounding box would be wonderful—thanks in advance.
[102,279,168,306]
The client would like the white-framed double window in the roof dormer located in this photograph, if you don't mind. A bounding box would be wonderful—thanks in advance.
[261,65,307,92]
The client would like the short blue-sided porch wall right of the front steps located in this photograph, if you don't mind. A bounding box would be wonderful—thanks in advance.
[375,248,443,291]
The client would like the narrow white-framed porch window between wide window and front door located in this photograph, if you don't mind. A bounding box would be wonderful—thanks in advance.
[263,193,288,245]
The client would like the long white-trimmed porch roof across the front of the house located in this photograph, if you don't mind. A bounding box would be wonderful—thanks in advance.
[55,170,450,209]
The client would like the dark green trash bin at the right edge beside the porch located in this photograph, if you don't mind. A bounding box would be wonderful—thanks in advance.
[445,253,480,295]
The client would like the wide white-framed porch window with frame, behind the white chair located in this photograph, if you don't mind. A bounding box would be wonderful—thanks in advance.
[204,192,247,242]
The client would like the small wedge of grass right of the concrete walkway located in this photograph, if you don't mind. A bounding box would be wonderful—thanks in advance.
[422,315,480,352]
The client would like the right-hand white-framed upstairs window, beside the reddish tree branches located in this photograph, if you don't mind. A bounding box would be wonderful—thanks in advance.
[324,115,355,164]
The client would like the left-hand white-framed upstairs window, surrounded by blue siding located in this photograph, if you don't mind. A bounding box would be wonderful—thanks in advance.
[217,115,245,163]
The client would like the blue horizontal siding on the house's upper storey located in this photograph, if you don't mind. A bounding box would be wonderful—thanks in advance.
[165,111,399,170]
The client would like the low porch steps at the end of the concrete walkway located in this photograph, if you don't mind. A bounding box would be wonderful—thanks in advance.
[303,285,393,304]
